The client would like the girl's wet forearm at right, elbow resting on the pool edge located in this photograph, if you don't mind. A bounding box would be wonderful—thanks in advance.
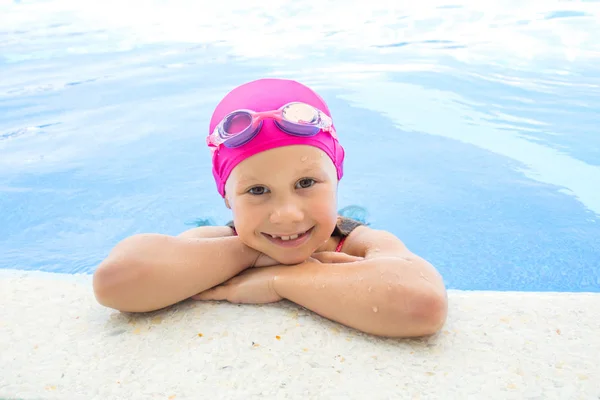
[275,258,447,337]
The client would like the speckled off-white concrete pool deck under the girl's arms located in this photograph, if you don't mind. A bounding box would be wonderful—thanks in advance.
[0,270,600,400]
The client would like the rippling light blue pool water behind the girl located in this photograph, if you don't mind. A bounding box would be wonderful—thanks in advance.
[0,0,600,292]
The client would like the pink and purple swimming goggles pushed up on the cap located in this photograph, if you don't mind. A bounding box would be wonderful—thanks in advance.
[206,102,336,149]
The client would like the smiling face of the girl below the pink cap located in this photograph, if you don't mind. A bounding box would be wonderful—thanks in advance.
[225,145,337,264]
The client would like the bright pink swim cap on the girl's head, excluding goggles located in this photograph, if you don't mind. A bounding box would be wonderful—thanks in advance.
[208,79,344,197]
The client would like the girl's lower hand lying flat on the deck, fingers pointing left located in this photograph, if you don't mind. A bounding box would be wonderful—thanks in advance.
[192,267,282,304]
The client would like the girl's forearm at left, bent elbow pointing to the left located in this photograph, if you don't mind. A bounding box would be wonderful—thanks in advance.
[94,234,258,312]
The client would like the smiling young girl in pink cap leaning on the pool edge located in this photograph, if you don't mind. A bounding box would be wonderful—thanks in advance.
[94,79,447,337]
